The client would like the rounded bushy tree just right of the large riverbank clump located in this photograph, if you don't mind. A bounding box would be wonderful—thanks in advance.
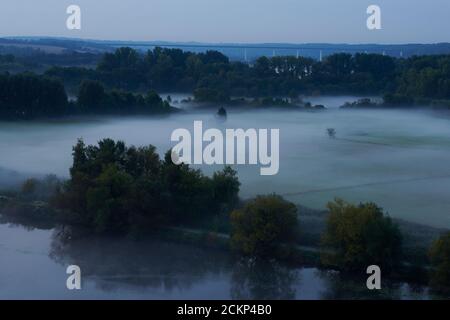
[231,195,298,257]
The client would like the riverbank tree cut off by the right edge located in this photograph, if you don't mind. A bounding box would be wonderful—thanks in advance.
[429,232,450,293]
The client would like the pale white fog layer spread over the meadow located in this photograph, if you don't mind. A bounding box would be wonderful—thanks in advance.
[0,97,450,228]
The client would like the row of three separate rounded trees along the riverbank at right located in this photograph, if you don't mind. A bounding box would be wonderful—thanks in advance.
[230,195,450,293]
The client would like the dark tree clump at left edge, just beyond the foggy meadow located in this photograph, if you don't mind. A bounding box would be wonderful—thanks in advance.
[0,73,175,120]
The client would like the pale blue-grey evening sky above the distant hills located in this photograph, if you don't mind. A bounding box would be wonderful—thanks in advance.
[0,0,450,43]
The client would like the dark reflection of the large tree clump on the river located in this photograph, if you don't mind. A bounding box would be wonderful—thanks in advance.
[50,228,230,293]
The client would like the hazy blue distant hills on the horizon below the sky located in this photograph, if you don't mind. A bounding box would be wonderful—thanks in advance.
[0,37,450,61]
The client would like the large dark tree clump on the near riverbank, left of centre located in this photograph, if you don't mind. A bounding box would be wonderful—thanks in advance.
[52,139,240,233]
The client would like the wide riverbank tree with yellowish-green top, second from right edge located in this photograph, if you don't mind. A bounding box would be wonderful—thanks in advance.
[321,199,401,273]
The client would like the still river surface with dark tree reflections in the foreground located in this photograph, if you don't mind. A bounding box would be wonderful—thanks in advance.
[0,224,434,299]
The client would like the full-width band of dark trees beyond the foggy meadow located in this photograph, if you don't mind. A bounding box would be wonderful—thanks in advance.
[0,48,450,119]
